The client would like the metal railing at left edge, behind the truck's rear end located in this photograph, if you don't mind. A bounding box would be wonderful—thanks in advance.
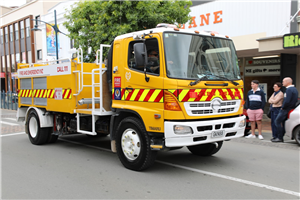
[0,91,18,110]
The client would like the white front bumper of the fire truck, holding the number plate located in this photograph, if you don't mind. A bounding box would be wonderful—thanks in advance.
[165,116,246,147]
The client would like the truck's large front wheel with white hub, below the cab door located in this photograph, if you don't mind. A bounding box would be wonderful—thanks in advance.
[116,117,157,171]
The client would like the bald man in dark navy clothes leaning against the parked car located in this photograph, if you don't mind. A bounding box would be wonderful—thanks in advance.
[271,77,298,142]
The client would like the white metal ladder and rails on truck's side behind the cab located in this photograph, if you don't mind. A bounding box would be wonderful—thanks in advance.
[73,44,113,135]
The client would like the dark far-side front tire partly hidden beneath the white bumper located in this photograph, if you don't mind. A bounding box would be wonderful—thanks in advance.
[187,141,223,156]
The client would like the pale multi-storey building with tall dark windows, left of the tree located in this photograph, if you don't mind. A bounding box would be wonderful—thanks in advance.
[0,0,65,92]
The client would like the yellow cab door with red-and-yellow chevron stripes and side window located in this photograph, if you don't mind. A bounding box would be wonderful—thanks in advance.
[124,34,164,132]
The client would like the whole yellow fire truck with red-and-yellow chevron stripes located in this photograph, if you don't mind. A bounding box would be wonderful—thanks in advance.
[17,24,245,171]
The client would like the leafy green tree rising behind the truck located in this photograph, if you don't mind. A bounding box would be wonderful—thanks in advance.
[64,0,192,62]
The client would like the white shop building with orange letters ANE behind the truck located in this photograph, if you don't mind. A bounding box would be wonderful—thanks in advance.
[182,0,300,111]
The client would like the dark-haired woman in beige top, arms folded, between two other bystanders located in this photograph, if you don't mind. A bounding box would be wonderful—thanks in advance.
[268,82,283,139]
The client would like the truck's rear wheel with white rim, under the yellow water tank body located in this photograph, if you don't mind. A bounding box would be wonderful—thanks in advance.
[25,110,49,145]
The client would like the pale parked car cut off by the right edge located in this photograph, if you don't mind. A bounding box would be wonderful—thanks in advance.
[285,100,300,145]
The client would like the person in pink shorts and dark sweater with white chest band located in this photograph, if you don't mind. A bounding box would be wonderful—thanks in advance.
[246,80,266,140]
